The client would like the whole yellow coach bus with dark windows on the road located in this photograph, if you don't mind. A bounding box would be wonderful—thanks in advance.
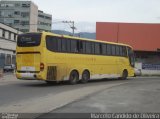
[16,32,134,84]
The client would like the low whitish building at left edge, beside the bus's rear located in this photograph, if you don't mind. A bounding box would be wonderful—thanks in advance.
[0,23,21,68]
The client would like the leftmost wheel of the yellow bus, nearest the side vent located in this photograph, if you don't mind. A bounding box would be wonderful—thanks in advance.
[69,71,79,85]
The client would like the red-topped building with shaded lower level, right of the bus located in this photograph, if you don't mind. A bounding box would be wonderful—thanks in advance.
[96,22,160,74]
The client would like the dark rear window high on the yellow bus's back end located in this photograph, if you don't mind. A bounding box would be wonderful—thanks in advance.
[17,34,41,47]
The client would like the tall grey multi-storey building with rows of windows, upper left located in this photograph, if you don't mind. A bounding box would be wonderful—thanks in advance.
[0,0,52,32]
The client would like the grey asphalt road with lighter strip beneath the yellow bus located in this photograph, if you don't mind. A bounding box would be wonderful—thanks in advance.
[0,77,160,118]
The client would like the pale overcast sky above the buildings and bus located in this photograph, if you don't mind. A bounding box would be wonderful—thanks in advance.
[32,0,160,32]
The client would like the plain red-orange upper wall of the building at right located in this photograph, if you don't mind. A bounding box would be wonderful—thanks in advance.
[96,22,160,51]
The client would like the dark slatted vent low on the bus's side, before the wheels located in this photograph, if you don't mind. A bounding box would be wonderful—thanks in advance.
[47,66,57,80]
